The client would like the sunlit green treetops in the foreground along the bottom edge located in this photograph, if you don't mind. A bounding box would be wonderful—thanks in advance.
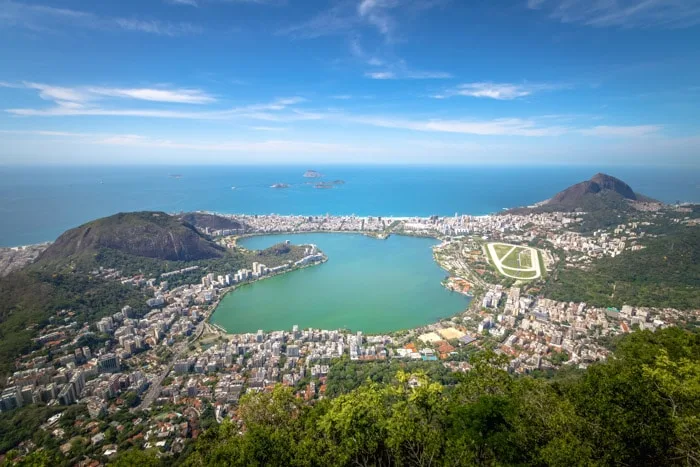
[172,329,700,466]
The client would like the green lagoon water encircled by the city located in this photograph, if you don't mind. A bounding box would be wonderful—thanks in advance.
[211,233,469,333]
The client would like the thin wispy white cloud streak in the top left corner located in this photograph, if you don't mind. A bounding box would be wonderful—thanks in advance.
[0,0,201,36]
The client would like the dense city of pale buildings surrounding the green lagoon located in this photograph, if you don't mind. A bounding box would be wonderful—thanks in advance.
[0,197,700,465]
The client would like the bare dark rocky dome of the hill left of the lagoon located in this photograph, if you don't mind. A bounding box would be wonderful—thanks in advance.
[39,212,225,263]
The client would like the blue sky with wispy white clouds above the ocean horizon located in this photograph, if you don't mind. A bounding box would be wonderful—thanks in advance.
[0,0,700,167]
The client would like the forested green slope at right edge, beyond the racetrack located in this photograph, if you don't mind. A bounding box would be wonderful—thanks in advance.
[543,227,700,309]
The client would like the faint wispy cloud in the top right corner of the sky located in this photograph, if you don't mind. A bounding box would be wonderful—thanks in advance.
[527,0,700,29]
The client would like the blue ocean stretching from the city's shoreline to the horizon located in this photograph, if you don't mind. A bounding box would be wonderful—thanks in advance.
[0,165,700,246]
